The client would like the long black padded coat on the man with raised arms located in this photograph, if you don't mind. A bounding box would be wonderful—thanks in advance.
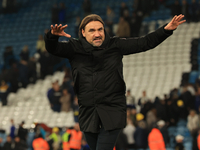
[44,24,172,133]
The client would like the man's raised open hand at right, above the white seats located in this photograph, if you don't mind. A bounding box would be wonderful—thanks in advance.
[164,14,186,30]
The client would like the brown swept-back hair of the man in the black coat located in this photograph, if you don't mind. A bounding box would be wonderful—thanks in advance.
[79,14,105,37]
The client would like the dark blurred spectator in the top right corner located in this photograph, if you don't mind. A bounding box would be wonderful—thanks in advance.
[189,0,199,22]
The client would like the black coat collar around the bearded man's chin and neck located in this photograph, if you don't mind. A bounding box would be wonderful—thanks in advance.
[79,30,110,52]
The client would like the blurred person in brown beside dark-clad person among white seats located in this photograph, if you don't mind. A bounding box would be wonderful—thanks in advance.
[60,89,71,112]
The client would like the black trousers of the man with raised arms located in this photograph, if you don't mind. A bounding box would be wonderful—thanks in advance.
[84,127,122,150]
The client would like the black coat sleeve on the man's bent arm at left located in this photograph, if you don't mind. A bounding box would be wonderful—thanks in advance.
[44,30,74,59]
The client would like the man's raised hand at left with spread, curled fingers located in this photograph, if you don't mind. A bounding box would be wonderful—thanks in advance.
[51,24,71,38]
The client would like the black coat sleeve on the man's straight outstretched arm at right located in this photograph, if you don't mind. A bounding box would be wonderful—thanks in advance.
[116,26,173,55]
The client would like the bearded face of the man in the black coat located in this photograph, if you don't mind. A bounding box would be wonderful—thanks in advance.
[82,21,105,47]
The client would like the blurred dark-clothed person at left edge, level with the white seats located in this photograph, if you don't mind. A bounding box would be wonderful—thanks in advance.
[0,80,9,106]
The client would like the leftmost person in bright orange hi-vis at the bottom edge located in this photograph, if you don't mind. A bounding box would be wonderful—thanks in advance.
[32,134,49,150]
